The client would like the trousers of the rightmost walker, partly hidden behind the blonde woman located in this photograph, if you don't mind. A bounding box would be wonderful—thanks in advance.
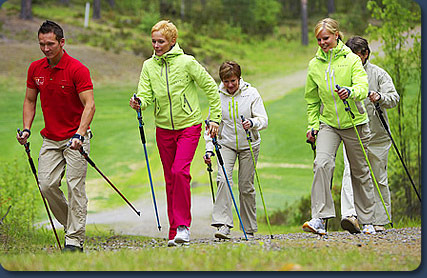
[341,141,391,225]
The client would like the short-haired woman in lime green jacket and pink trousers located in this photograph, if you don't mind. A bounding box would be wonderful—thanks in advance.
[129,20,221,246]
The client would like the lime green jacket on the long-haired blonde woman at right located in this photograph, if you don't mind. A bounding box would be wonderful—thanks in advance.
[304,40,369,132]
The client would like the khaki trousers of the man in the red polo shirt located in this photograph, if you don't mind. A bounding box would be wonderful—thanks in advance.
[38,135,90,247]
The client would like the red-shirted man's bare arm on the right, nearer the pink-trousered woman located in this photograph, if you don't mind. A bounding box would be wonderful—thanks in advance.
[71,90,95,150]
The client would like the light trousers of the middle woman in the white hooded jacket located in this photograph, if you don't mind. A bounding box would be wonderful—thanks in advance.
[211,145,260,233]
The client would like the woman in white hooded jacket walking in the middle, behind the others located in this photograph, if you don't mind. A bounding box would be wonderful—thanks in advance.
[203,61,268,239]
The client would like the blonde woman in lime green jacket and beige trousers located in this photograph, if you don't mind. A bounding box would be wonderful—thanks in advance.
[303,18,375,234]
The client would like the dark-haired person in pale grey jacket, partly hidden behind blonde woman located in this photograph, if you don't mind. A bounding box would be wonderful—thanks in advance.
[341,36,400,233]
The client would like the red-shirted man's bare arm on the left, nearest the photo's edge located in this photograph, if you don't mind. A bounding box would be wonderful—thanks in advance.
[16,87,38,145]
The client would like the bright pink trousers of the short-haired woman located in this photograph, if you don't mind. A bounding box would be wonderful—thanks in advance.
[156,124,202,239]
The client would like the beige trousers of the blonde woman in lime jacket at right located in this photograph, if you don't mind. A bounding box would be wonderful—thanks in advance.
[311,123,374,224]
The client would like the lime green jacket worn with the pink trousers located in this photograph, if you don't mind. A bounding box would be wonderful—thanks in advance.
[137,43,221,130]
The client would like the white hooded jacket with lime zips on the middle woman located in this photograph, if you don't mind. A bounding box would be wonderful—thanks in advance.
[204,78,268,152]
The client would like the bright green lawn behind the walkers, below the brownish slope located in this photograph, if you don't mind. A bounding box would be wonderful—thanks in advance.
[0,80,312,213]
